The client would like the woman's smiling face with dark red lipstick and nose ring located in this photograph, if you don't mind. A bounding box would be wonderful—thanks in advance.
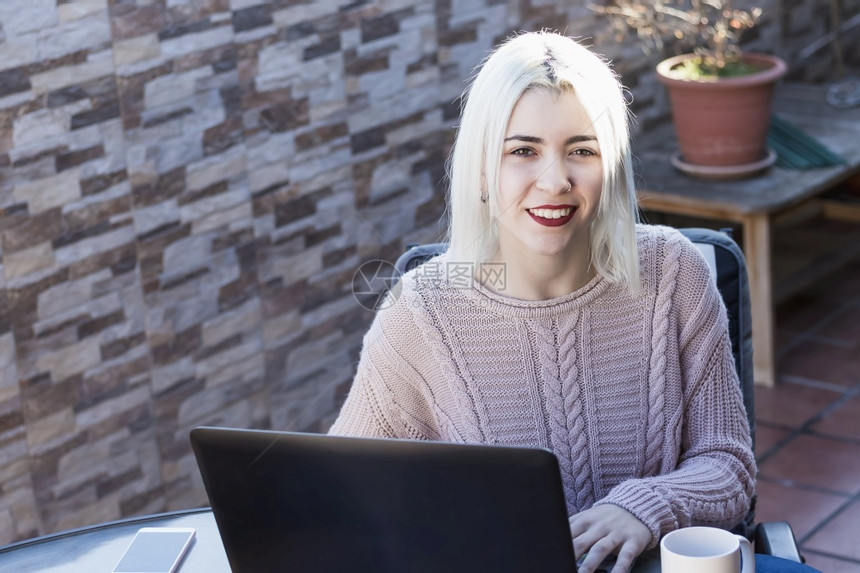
[490,89,603,266]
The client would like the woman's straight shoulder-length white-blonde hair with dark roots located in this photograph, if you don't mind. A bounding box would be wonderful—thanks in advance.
[448,32,639,291]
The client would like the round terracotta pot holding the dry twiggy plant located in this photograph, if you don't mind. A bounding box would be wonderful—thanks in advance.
[657,54,788,176]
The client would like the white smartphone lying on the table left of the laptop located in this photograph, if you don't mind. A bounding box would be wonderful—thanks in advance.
[113,527,195,573]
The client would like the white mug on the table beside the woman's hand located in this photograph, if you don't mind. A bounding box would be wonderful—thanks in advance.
[660,527,755,573]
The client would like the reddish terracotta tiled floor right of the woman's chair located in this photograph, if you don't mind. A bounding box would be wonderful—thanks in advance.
[756,236,860,573]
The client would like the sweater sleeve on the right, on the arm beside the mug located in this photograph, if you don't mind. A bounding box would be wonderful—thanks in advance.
[596,230,756,547]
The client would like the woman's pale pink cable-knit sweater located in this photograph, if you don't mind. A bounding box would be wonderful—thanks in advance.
[330,225,756,546]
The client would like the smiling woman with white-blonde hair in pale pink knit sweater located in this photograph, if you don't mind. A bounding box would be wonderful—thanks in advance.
[330,32,808,573]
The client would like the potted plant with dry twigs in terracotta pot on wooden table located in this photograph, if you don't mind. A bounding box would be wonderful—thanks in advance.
[592,0,787,178]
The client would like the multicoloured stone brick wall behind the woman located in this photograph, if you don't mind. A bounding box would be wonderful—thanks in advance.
[0,0,848,544]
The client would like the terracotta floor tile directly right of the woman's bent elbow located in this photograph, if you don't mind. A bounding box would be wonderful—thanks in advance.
[759,435,860,492]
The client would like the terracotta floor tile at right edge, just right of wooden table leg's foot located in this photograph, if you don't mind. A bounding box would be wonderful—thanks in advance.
[777,340,860,387]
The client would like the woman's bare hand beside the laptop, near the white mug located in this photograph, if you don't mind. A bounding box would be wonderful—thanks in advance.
[568,503,651,573]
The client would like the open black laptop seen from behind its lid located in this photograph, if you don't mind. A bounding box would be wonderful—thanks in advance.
[191,427,576,573]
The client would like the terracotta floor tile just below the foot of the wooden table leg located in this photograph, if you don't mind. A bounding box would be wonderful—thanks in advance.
[755,380,842,427]
